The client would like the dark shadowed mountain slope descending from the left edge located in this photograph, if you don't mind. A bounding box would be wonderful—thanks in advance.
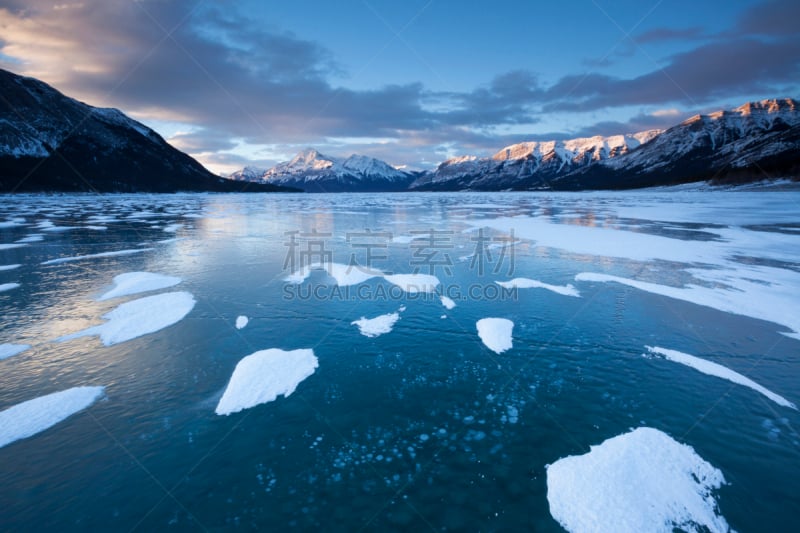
[0,70,294,192]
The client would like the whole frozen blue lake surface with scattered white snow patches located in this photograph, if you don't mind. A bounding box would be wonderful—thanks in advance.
[0,191,800,531]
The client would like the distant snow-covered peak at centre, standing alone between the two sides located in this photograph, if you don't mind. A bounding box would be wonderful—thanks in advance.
[232,148,416,192]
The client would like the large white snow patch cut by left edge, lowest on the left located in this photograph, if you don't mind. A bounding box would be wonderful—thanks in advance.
[0,387,103,448]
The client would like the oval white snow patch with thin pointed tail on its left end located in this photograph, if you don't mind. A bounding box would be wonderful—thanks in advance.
[58,292,195,346]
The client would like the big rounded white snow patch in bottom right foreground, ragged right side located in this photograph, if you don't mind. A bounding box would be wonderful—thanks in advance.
[547,427,730,533]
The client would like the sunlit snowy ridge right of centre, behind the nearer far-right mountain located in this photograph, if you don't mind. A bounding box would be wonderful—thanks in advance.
[411,130,661,190]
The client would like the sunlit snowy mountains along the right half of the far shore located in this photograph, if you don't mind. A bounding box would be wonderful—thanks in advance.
[411,98,800,190]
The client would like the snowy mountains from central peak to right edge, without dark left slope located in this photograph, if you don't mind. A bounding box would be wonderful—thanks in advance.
[232,98,800,192]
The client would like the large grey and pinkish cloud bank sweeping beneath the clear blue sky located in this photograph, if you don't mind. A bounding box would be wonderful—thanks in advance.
[0,0,800,170]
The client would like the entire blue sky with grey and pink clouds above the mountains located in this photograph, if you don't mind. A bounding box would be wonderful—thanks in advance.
[0,0,800,172]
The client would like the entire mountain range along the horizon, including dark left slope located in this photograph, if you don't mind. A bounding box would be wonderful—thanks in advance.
[0,66,800,192]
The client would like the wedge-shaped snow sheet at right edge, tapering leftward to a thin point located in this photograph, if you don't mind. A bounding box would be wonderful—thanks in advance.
[575,266,800,338]
